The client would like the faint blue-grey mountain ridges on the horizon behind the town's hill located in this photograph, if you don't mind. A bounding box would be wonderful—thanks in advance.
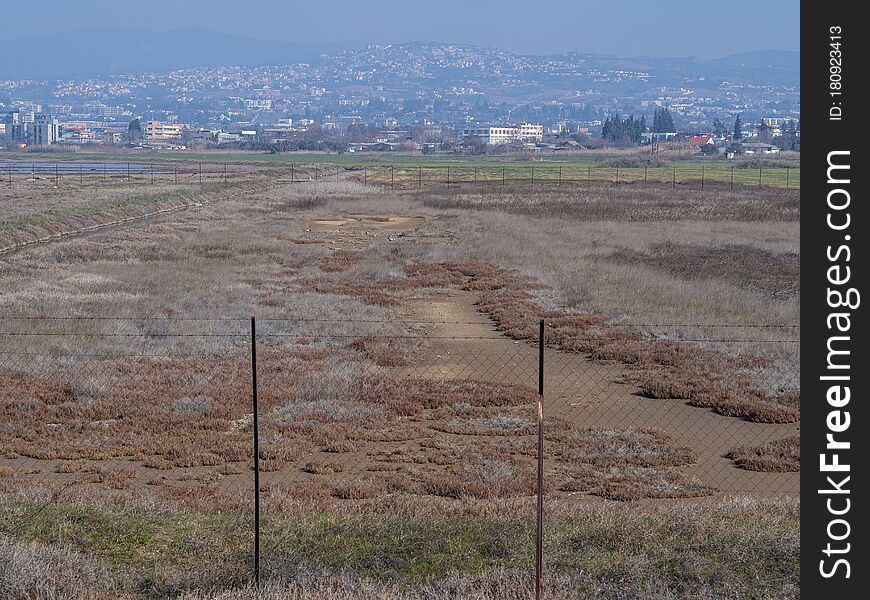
[0,28,800,82]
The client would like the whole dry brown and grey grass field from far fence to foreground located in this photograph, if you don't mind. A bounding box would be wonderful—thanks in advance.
[0,171,800,600]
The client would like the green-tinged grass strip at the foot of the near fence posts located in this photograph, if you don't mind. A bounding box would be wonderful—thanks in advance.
[0,502,800,598]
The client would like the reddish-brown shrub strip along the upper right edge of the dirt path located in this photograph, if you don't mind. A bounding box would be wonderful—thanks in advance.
[398,262,800,423]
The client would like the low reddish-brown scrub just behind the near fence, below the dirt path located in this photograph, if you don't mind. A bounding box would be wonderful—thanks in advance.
[0,338,714,507]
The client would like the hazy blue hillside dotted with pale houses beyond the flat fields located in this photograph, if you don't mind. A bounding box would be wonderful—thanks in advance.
[0,44,800,154]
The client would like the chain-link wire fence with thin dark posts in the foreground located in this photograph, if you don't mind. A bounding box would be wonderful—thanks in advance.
[0,316,800,578]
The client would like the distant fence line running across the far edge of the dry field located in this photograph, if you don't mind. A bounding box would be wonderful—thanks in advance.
[0,161,800,190]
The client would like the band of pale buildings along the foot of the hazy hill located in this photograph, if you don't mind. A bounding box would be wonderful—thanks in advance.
[0,106,800,158]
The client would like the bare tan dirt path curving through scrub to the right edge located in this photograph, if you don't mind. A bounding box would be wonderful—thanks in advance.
[407,291,800,496]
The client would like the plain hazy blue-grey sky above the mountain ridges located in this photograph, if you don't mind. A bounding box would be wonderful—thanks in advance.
[0,0,800,57]
